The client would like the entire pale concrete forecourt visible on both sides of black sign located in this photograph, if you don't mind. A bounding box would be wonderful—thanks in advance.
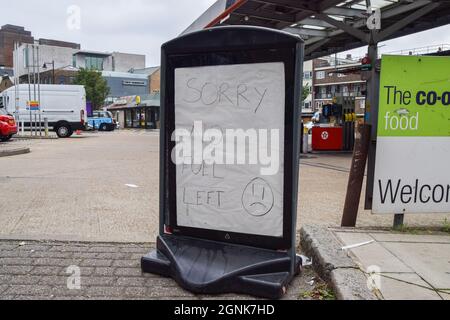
[0,130,450,242]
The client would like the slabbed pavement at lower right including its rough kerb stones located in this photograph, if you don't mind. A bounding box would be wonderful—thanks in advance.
[301,225,450,300]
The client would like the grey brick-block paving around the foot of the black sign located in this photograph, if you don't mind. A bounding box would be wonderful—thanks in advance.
[0,240,324,300]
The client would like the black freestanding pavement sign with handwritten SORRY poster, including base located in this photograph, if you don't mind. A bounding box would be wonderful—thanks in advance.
[142,27,303,297]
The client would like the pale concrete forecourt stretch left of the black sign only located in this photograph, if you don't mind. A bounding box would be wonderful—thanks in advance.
[0,132,159,242]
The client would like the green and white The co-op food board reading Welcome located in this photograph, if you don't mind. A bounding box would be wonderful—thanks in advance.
[373,56,450,214]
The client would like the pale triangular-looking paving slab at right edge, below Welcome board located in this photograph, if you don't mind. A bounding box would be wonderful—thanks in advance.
[383,242,450,289]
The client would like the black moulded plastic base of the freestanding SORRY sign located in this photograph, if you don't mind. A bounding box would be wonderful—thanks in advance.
[141,235,302,299]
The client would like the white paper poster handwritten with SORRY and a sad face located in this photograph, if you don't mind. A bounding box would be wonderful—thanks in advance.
[173,62,285,237]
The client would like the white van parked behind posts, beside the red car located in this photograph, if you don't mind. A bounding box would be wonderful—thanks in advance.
[0,84,87,138]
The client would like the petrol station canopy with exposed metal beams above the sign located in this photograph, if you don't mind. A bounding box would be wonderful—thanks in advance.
[183,0,450,60]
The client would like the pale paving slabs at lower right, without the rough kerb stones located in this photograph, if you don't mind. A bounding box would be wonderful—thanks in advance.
[333,229,450,300]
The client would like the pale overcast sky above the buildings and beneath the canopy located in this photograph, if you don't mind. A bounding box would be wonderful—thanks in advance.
[0,0,450,66]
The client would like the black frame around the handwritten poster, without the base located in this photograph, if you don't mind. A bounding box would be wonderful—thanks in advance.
[160,27,304,250]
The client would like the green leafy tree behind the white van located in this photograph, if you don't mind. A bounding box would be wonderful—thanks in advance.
[74,69,110,110]
